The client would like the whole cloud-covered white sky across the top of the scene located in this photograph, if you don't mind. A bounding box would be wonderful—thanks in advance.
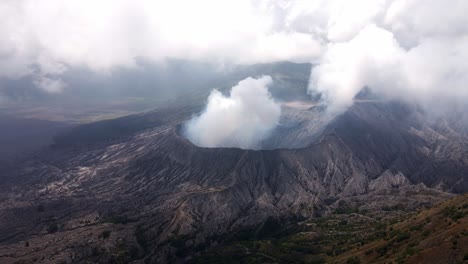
[0,0,468,148]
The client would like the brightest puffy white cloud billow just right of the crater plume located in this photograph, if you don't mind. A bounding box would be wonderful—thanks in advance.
[309,25,404,112]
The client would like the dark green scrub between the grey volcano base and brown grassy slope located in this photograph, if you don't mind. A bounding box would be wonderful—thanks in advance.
[194,215,386,263]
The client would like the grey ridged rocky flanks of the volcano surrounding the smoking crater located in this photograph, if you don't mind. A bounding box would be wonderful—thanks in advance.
[0,98,468,261]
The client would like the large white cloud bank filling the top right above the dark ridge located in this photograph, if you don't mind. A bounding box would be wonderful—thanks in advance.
[309,0,468,113]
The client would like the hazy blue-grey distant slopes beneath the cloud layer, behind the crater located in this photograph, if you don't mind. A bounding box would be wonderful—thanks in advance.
[0,59,312,116]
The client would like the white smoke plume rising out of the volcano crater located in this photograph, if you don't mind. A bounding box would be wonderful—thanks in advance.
[183,76,281,149]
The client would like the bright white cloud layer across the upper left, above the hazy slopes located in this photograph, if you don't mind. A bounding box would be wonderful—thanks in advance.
[0,0,320,86]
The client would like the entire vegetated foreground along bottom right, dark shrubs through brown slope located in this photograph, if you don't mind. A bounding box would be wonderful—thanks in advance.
[193,195,468,263]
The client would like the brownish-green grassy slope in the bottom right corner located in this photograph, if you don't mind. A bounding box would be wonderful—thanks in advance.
[336,195,468,263]
